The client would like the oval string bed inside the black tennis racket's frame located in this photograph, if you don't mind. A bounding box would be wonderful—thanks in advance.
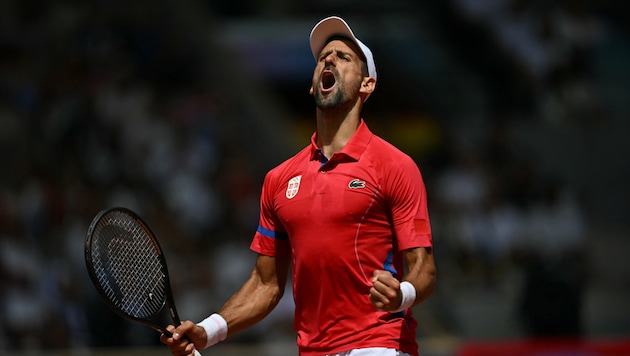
[92,213,167,318]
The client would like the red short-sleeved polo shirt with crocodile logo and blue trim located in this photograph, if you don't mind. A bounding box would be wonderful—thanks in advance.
[251,121,432,355]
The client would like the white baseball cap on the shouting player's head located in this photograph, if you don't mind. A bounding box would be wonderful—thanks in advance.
[310,16,376,80]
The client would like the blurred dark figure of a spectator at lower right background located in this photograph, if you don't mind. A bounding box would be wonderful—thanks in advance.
[520,182,589,338]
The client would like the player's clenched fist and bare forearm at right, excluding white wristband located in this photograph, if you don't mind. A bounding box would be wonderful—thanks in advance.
[370,247,436,311]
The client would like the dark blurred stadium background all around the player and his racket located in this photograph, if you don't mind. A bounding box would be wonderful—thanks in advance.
[0,0,630,355]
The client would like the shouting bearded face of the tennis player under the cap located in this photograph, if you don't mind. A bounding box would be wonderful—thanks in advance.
[310,39,364,109]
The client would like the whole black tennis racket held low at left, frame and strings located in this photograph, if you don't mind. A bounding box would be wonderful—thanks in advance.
[85,208,201,355]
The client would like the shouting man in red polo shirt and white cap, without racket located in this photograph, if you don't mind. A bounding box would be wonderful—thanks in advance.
[161,17,436,356]
